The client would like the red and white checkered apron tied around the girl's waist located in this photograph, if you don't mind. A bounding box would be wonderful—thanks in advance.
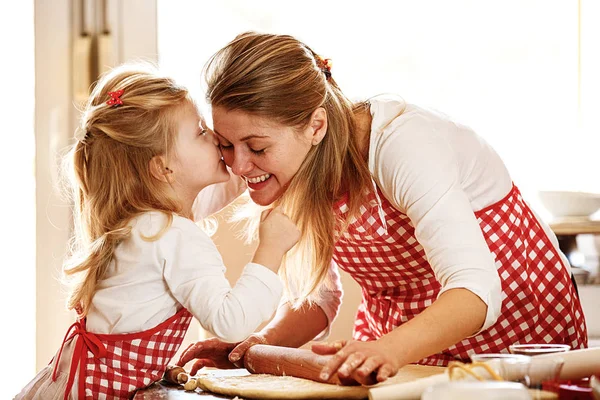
[52,308,192,400]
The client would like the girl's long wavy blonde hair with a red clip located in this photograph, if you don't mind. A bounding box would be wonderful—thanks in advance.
[64,63,193,316]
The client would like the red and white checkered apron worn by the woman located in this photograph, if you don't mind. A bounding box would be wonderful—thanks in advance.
[333,186,587,366]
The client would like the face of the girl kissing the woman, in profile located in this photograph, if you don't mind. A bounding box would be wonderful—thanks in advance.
[169,104,229,199]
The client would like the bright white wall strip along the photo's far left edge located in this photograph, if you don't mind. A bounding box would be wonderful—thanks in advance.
[0,1,36,399]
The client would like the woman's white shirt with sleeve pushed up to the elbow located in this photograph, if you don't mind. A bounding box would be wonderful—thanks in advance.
[318,95,569,330]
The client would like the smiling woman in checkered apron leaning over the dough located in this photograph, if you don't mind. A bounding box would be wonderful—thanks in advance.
[180,32,587,383]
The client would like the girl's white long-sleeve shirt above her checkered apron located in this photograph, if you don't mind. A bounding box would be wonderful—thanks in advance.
[87,208,283,342]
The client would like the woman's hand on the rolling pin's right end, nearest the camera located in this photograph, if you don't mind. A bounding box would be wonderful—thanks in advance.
[312,340,400,385]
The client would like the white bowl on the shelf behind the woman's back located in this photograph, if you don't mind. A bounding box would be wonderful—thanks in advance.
[539,190,600,218]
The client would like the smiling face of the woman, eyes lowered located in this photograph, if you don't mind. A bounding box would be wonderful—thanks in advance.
[212,107,327,206]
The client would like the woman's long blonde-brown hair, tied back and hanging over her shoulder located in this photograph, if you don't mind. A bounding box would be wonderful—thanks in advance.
[205,32,372,306]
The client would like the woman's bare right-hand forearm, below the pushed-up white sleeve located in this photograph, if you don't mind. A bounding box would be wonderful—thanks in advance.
[379,289,487,365]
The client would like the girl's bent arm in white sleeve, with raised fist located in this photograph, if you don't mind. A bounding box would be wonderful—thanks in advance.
[157,214,292,342]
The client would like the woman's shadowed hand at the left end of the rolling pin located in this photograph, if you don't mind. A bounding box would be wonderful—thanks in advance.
[177,333,266,376]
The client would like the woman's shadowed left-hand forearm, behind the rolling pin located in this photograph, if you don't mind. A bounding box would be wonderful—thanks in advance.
[261,303,328,347]
